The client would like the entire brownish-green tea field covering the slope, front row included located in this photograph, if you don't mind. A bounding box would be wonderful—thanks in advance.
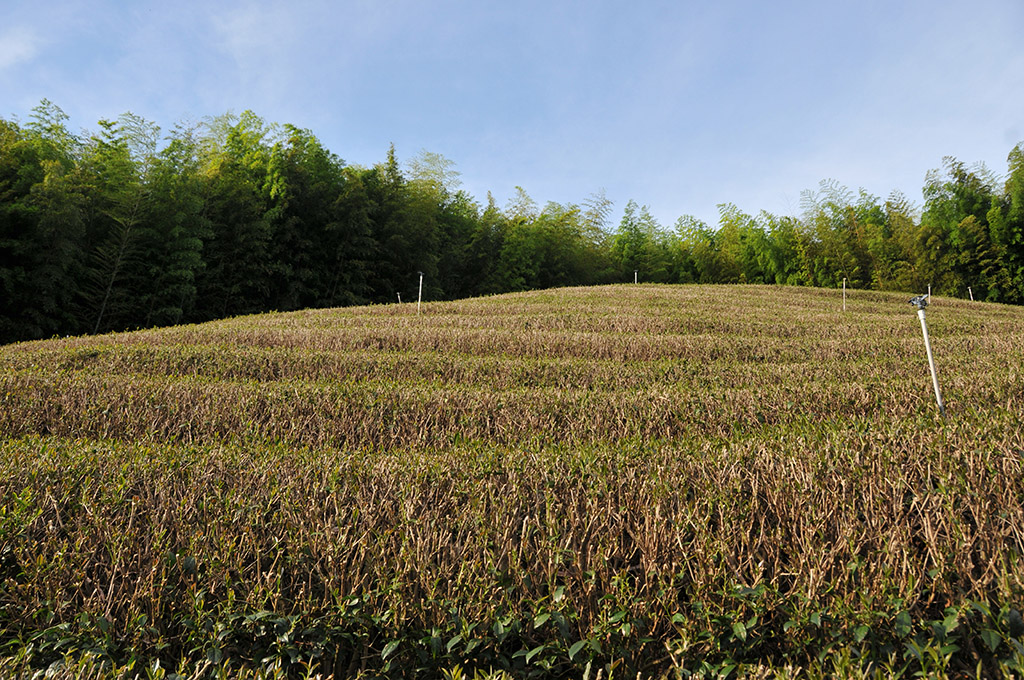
[0,286,1024,676]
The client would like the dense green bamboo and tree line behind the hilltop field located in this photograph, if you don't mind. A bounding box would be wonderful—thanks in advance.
[6,100,1024,342]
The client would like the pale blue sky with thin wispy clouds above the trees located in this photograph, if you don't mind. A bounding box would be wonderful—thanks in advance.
[0,0,1024,227]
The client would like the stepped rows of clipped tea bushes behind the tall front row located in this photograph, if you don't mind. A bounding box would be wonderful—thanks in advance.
[0,286,1024,448]
